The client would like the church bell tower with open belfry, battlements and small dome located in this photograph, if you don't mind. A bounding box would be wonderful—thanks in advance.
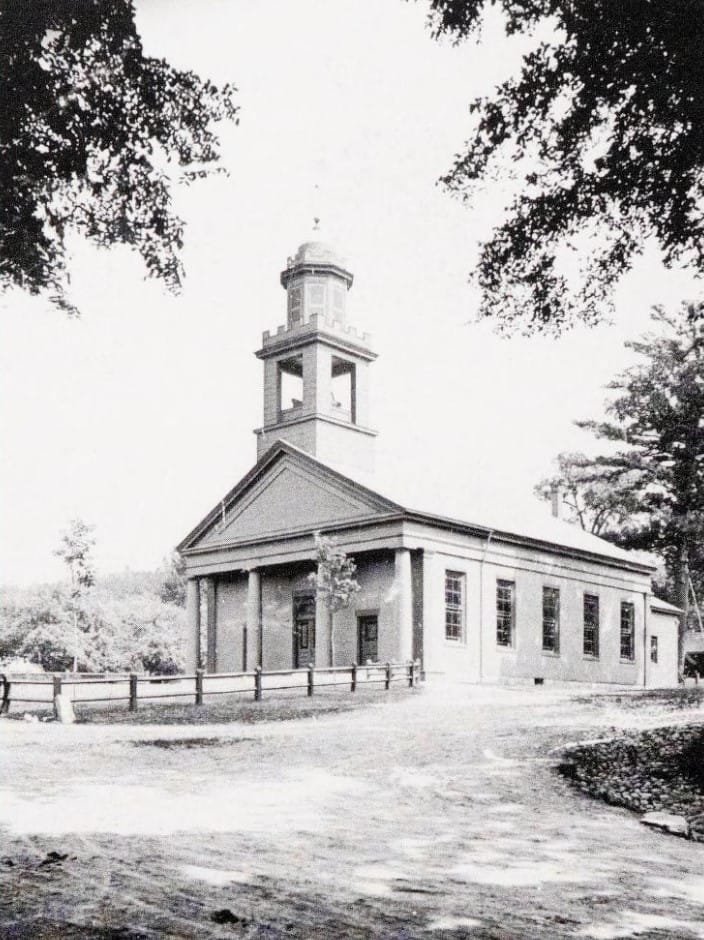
[254,241,376,473]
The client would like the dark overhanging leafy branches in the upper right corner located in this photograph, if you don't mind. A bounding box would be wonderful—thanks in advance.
[430,0,704,332]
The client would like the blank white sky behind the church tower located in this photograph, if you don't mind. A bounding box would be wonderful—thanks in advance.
[0,0,695,584]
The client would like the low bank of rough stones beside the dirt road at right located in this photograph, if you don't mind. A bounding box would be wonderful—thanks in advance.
[559,725,704,842]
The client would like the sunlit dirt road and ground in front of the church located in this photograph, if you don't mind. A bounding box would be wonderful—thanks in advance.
[0,686,704,940]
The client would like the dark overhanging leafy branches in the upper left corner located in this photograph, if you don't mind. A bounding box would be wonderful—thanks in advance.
[0,0,237,313]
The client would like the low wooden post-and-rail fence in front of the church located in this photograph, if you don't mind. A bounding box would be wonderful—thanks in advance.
[0,660,420,714]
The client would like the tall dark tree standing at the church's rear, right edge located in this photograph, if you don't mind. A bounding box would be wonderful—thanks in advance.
[540,305,704,666]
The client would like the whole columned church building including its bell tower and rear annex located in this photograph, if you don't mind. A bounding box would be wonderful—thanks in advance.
[178,241,678,687]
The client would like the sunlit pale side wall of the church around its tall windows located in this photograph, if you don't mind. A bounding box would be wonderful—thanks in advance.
[415,530,660,685]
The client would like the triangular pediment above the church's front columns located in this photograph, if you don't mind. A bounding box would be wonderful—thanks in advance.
[180,445,400,550]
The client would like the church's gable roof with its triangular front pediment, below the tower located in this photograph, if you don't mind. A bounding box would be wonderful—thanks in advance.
[178,441,655,572]
